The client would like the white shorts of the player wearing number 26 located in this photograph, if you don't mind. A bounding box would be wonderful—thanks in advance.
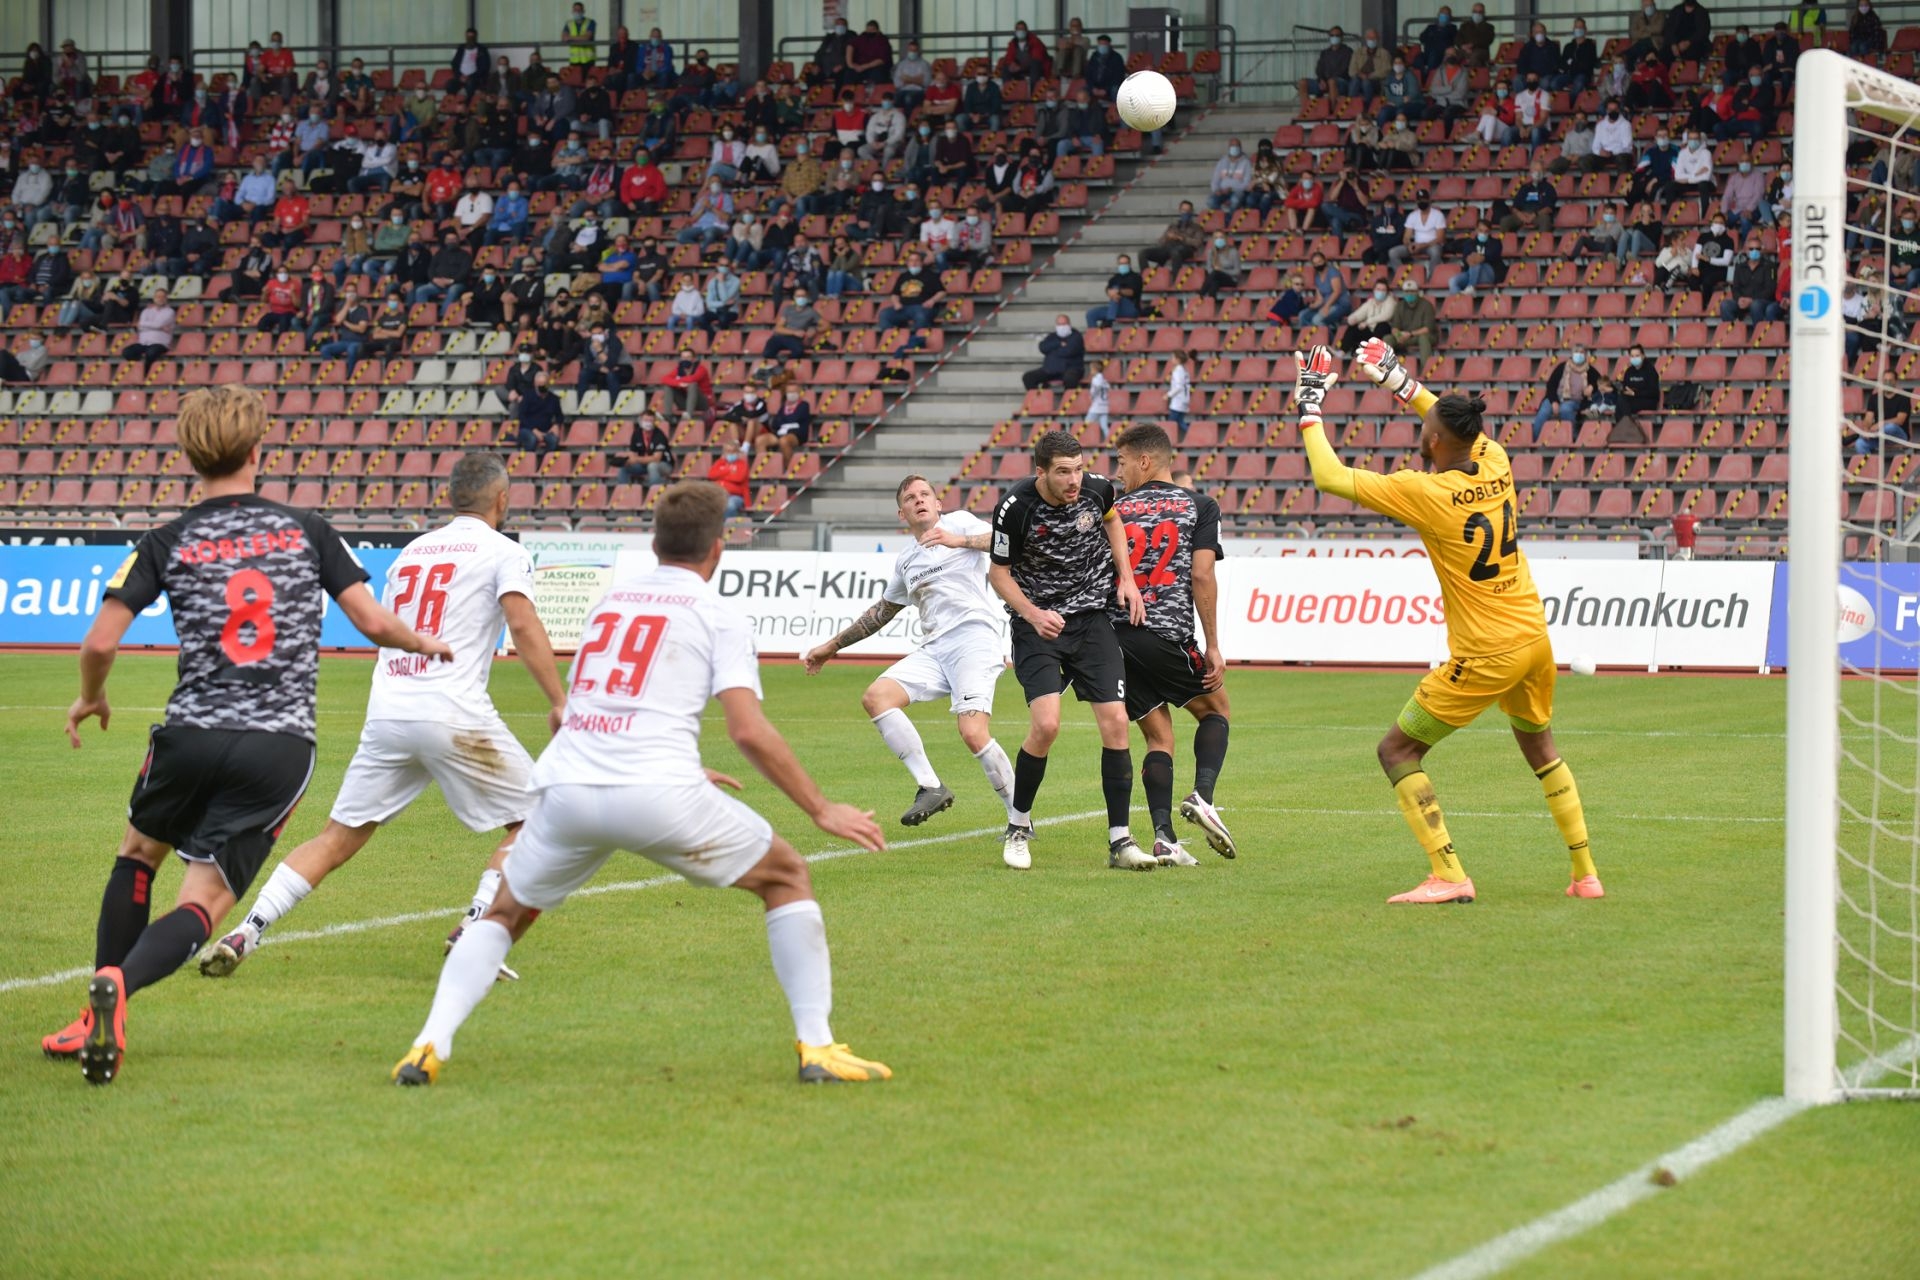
[332,720,534,831]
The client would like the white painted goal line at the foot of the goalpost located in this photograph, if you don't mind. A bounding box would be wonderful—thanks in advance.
[1413,1036,1920,1280]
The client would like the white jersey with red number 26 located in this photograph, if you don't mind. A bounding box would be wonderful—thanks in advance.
[367,516,534,729]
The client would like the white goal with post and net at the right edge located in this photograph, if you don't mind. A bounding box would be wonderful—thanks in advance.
[1786,50,1920,1102]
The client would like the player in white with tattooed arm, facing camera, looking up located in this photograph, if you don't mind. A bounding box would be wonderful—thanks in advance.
[801,476,1014,827]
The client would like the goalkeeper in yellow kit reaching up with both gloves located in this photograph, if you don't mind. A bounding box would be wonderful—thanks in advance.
[1294,338,1603,904]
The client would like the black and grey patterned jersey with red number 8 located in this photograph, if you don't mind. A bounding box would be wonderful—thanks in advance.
[106,493,367,743]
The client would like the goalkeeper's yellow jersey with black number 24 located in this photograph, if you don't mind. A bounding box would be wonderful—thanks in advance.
[1354,436,1548,658]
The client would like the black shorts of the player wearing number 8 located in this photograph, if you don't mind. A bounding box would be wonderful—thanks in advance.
[127,725,313,896]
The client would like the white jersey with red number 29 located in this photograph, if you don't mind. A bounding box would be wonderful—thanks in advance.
[534,564,760,791]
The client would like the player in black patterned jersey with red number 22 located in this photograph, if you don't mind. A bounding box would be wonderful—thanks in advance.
[1110,422,1235,867]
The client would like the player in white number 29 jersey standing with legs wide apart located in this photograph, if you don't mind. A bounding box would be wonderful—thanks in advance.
[392,480,893,1084]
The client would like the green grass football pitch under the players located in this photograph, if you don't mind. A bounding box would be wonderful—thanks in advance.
[0,654,1920,1280]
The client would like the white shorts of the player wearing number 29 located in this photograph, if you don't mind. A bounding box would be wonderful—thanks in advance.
[501,781,774,912]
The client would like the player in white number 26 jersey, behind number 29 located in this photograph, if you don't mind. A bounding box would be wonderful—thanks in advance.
[200,453,566,977]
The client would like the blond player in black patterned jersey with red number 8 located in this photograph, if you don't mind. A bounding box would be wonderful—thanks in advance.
[40,386,453,1084]
